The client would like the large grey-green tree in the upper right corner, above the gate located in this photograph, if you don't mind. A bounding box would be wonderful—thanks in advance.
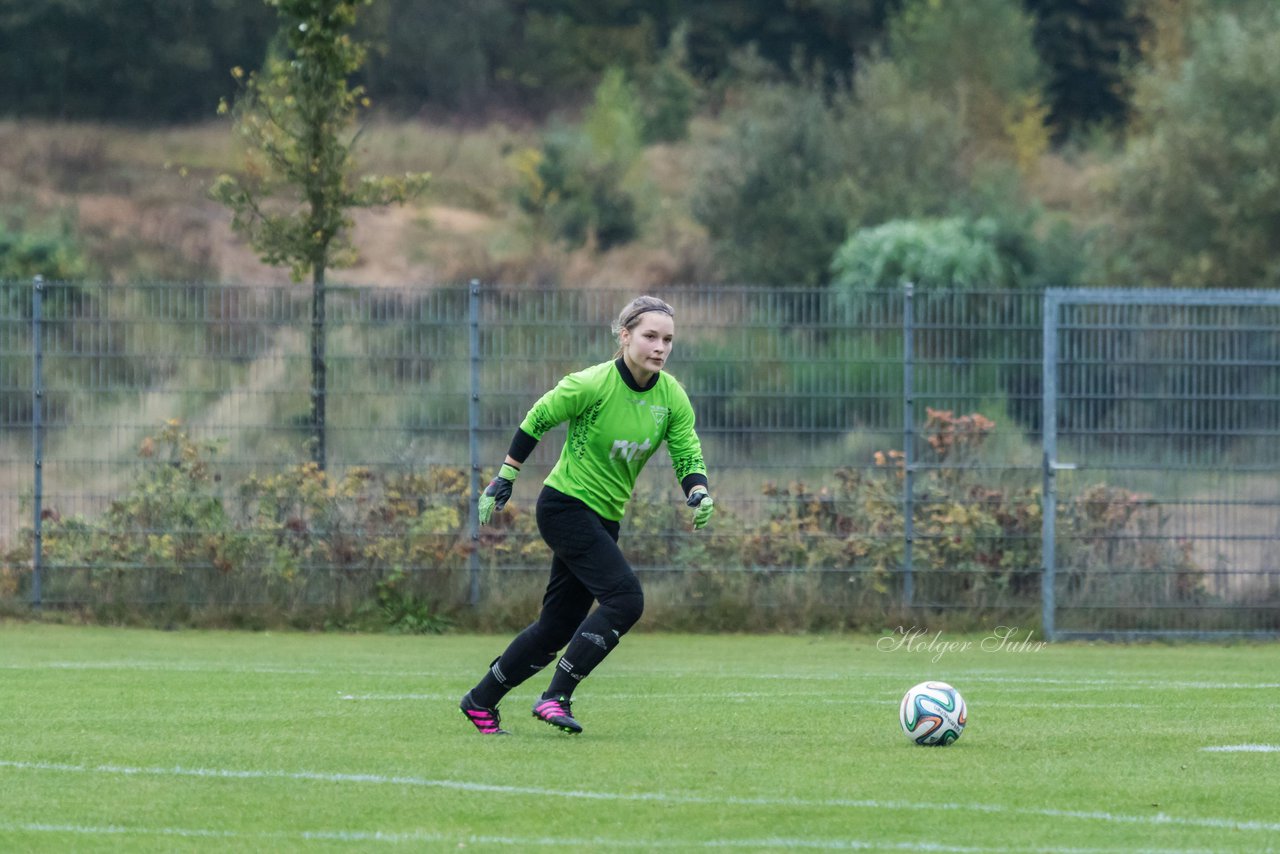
[1107,4,1280,288]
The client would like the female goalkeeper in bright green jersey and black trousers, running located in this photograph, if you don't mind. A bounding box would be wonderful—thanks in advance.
[460,297,714,735]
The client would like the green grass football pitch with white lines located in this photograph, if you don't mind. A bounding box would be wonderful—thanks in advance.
[0,624,1280,851]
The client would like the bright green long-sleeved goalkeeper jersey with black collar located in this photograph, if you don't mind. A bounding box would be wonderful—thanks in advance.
[520,359,707,521]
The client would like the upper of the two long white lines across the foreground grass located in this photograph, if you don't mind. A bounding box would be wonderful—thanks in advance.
[0,759,1280,834]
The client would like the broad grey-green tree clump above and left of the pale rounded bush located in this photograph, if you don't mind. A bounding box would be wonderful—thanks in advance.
[692,60,968,287]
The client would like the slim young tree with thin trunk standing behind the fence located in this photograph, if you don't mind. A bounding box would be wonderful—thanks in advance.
[211,0,429,469]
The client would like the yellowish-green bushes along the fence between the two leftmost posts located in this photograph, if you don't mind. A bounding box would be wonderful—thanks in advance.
[5,421,470,631]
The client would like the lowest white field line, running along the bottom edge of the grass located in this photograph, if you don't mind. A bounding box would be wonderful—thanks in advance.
[0,823,1218,854]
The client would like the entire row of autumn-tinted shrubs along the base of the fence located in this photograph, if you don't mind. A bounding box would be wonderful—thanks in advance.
[0,410,1208,632]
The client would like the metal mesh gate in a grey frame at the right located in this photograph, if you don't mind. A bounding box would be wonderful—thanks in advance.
[1044,291,1280,634]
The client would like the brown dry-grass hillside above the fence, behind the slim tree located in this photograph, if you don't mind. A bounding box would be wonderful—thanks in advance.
[0,120,707,287]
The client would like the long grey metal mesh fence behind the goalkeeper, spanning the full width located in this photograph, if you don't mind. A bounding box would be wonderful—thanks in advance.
[0,282,1280,630]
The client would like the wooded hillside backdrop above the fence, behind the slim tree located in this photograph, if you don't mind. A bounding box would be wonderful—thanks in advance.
[0,0,1280,294]
